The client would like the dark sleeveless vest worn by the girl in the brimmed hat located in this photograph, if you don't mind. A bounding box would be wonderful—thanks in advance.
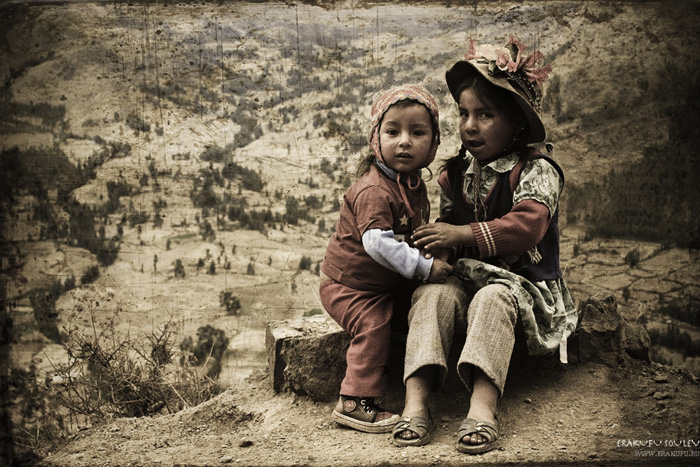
[448,149,564,281]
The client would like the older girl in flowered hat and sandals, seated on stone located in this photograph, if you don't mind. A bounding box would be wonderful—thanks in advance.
[392,36,578,453]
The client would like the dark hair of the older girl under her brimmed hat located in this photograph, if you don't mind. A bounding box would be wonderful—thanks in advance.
[439,73,530,176]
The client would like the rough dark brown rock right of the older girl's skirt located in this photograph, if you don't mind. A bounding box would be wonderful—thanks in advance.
[570,295,651,366]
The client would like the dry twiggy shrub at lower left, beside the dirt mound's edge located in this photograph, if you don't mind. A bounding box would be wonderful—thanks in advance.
[57,317,216,419]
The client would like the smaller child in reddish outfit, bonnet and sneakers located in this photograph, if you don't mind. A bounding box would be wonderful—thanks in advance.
[320,85,451,433]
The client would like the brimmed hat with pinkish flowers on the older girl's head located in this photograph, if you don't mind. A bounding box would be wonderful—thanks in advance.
[445,35,552,143]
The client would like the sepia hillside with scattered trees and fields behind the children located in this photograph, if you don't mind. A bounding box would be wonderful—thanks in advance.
[0,1,700,464]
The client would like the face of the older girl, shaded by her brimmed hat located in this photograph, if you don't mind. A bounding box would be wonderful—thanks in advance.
[459,88,516,163]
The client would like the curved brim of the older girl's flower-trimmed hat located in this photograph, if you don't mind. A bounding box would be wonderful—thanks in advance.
[445,60,547,143]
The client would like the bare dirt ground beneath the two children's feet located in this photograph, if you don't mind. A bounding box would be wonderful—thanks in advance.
[42,354,700,467]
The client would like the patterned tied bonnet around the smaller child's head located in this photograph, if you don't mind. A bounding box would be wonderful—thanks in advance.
[369,84,440,168]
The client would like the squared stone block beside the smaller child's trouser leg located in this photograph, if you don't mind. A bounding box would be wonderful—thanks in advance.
[265,315,350,402]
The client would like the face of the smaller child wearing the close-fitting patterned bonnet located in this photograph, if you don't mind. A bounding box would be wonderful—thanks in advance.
[379,103,433,172]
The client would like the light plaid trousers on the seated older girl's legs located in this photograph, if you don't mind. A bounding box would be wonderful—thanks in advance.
[404,276,518,395]
